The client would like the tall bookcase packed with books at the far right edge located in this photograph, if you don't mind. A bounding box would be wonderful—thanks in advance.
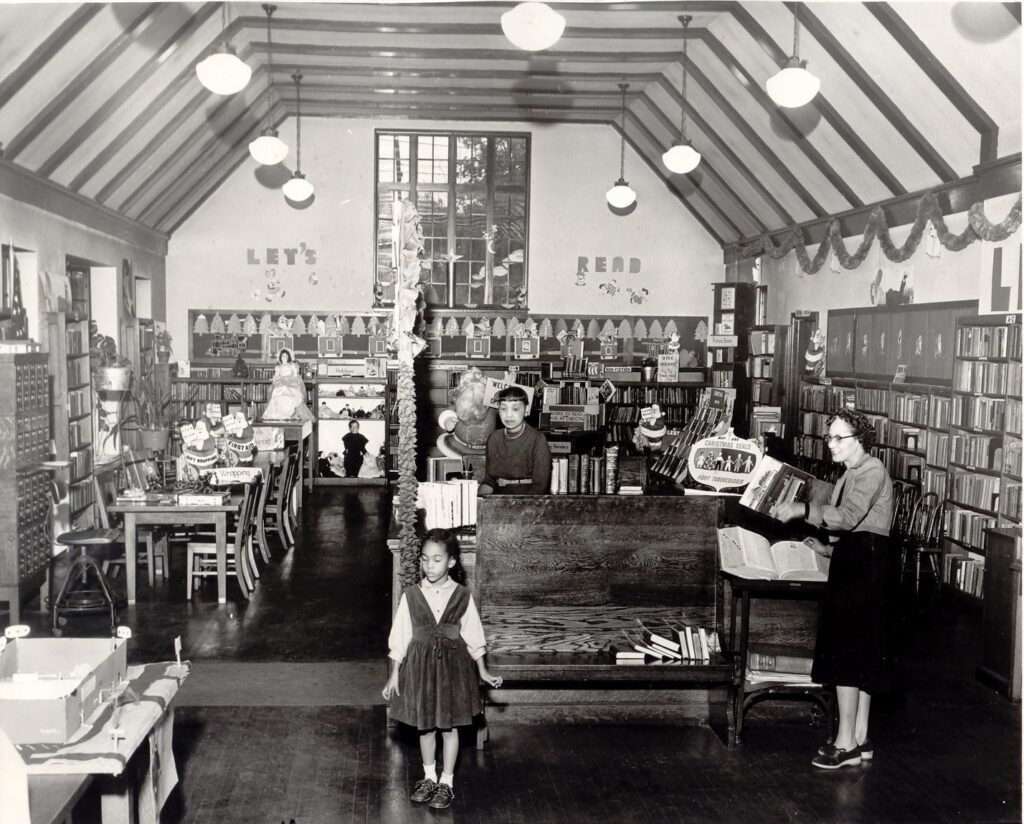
[942,314,1021,597]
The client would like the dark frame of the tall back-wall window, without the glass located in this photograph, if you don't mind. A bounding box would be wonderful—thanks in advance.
[373,128,532,311]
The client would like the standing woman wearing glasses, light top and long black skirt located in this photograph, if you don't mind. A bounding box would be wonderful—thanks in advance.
[776,409,898,770]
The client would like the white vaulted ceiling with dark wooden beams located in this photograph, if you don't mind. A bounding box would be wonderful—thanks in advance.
[0,0,1021,245]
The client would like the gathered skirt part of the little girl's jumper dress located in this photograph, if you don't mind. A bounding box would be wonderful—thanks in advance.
[391,636,483,730]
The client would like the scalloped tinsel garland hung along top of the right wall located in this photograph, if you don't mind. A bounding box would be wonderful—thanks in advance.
[738,191,1021,274]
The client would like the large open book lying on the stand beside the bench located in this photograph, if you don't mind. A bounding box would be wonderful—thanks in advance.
[718,526,828,580]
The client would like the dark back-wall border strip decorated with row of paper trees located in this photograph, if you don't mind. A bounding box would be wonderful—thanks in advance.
[188,309,708,366]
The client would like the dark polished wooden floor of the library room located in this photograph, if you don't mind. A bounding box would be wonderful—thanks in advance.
[6,487,1021,824]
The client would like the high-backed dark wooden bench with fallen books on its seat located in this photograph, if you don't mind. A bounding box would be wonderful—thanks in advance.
[472,495,738,746]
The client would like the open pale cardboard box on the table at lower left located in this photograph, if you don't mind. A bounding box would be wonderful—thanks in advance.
[0,638,128,744]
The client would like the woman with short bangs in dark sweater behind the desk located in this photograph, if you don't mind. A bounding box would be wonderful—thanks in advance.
[480,386,551,495]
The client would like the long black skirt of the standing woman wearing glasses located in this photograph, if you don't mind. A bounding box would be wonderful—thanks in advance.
[811,532,900,694]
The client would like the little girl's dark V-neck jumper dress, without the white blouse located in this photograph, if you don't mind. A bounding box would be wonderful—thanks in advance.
[391,583,483,730]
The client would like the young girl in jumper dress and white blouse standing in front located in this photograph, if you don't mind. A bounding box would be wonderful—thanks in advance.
[383,529,502,810]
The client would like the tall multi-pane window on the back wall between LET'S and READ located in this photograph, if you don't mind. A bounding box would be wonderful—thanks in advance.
[374,132,529,309]
